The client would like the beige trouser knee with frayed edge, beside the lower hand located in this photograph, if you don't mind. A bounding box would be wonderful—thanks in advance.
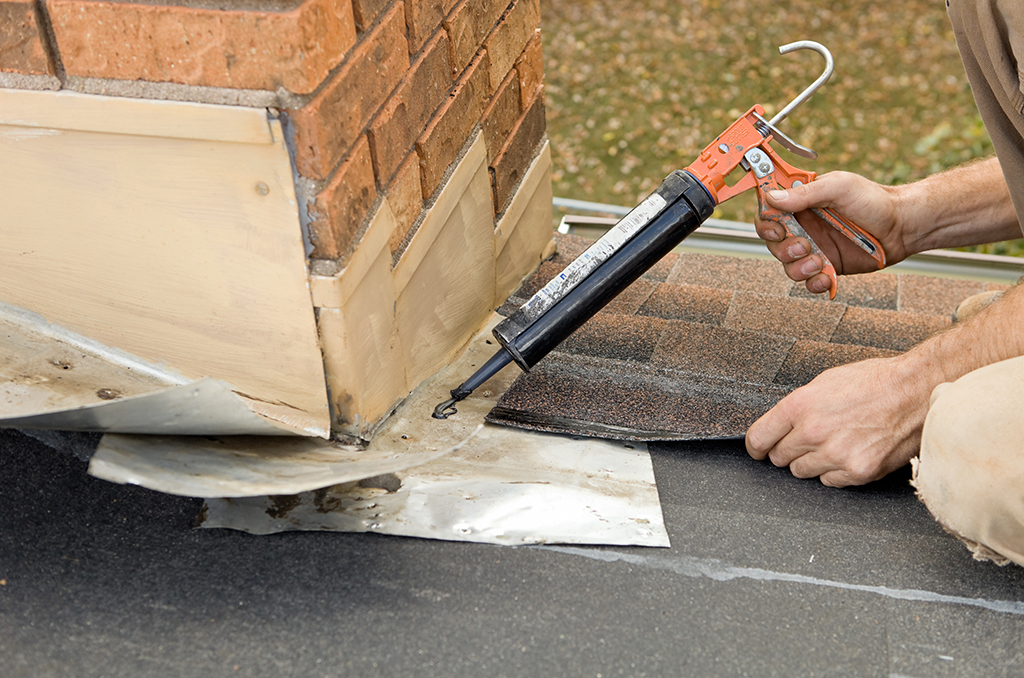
[912,357,1024,565]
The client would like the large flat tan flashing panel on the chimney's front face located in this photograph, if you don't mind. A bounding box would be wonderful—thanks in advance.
[0,92,330,436]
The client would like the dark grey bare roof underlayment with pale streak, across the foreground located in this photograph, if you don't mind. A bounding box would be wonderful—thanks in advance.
[0,430,1024,678]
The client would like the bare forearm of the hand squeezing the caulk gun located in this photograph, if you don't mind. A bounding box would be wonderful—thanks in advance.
[890,158,1021,254]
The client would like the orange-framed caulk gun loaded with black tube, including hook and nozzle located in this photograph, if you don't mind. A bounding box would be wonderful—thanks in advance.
[433,40,886,419]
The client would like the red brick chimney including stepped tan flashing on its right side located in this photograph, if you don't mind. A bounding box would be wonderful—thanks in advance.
[0,0,551,437]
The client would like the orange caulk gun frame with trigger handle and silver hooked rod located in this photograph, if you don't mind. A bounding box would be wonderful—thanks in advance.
[686,40,886,299]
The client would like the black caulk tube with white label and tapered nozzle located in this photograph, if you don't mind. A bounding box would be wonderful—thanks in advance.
[433,170,715,419]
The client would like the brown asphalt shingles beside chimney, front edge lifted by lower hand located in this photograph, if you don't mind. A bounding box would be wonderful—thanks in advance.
[487,236,972,440]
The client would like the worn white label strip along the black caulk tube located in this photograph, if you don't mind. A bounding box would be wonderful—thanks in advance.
[522,193,669,317]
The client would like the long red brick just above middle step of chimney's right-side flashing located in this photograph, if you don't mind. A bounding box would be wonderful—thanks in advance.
[416,51,487,200]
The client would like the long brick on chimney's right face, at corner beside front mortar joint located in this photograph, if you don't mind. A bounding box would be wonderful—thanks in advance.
[291,2,409,179]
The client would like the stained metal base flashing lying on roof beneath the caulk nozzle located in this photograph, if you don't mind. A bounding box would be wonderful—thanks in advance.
[90,315,669,546]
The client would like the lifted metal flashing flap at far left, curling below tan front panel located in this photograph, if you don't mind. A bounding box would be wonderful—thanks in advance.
[0,303,318,435]
